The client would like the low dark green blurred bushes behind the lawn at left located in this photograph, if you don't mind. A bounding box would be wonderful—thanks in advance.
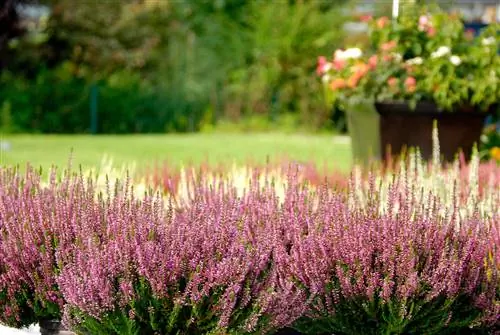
[0,67,202,133]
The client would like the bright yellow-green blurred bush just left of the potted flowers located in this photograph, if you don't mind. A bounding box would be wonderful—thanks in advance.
[225,1,344,127]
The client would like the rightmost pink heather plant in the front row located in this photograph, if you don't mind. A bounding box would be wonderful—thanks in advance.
[277,178,500,334]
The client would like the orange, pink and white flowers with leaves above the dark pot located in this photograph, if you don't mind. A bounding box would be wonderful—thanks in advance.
[317,7,500,111]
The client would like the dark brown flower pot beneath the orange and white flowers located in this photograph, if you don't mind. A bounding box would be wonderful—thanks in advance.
[375,102,496,162]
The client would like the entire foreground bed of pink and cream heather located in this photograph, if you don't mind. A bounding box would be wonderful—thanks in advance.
[0,154,500,335]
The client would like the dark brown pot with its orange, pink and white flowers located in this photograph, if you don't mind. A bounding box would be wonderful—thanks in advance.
[318,7,500,161]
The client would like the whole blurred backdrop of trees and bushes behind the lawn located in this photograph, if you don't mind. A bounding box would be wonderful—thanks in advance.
[0,0,500,134]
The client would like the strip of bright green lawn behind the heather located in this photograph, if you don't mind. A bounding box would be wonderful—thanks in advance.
[0,133,351,171]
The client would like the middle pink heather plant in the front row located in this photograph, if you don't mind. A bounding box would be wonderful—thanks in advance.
[58,175,304,334]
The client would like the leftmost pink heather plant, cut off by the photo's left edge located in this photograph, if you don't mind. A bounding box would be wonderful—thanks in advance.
[0,167,99,327]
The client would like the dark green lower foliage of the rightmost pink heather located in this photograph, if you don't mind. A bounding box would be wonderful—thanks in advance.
[295,296,486,335]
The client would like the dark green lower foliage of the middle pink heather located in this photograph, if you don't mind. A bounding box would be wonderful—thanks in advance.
[69,279,270,335]
